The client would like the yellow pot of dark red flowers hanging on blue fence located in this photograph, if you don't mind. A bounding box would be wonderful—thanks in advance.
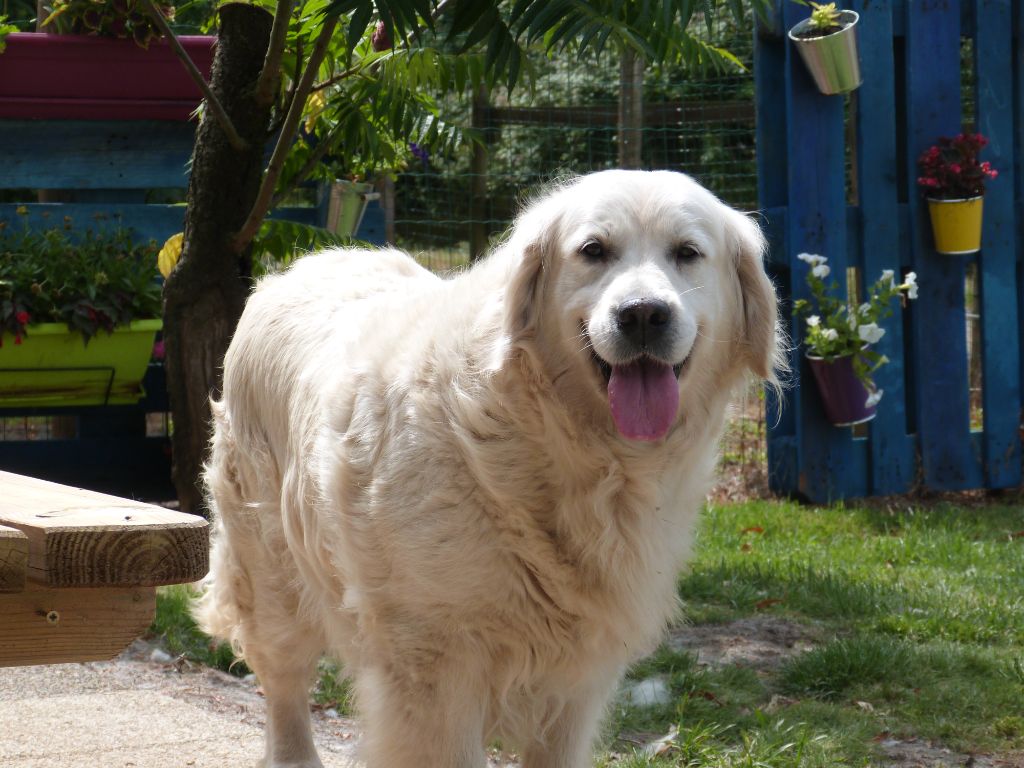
[918,133,999,256]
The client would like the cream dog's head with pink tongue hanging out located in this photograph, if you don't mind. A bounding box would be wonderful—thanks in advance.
[505,171,778,440]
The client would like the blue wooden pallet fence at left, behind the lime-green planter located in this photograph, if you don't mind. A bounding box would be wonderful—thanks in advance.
[0,115,384,499]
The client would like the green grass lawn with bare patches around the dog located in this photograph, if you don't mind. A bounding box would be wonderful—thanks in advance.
[154,502,1024,768]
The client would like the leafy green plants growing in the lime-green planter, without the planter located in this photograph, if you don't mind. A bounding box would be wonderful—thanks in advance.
[0,208,161,344]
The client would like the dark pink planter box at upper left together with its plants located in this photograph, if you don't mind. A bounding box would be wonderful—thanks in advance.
[0,0,215,121]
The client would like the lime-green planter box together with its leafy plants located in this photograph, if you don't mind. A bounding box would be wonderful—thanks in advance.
[0,206,162,407]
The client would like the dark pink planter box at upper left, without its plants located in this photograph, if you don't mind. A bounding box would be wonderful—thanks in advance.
[0,32,216,121]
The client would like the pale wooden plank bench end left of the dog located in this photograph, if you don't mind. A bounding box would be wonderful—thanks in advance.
[0,472,209,667]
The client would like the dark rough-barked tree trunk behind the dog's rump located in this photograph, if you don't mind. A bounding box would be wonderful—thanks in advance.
[164,3,272,513]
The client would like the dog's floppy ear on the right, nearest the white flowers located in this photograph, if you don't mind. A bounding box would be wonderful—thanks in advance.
[730,211,784,382]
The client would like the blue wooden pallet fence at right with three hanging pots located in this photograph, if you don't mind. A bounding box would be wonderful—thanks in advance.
[755,0,1024,502]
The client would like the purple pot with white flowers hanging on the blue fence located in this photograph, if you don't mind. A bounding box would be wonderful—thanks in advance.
[794,253,918,427]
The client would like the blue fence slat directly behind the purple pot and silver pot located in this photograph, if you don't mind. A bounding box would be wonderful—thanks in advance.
[782,3,867,502]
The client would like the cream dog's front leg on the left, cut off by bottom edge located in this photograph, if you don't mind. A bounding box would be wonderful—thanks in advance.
[356,659,486,768]
